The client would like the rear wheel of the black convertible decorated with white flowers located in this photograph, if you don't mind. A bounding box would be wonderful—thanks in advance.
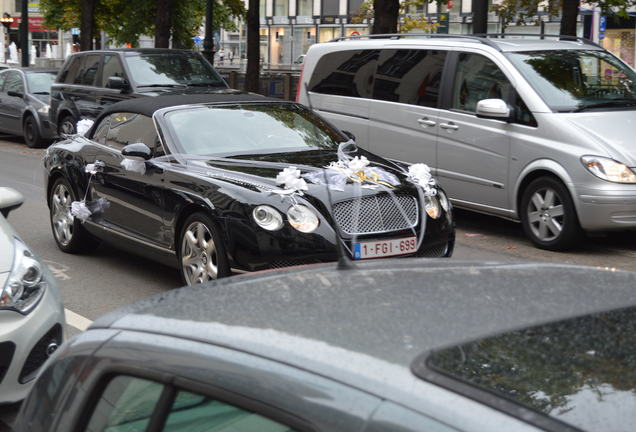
[49,177,99,253]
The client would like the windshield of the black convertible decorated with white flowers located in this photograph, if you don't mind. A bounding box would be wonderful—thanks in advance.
[166,103,343,156]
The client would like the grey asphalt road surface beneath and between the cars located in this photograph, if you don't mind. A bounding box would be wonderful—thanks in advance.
[0,137,636,432]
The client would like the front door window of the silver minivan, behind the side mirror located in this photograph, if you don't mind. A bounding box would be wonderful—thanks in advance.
[451,53,512,113]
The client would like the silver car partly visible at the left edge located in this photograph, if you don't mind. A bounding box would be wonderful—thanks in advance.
[0,187,64,405]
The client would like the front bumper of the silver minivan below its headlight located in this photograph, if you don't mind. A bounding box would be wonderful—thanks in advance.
[576,185,636,231]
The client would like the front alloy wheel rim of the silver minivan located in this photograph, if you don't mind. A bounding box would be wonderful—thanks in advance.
[527,188,565,242]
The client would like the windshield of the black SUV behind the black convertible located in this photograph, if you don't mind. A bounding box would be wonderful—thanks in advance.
[125,52,226,87]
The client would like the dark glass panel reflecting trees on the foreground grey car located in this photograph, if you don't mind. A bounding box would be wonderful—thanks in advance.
[427,307,636,432]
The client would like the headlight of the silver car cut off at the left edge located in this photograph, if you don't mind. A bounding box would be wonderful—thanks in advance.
[0,238,46,314]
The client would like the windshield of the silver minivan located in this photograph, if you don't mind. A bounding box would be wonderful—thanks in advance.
[507,50,636,112]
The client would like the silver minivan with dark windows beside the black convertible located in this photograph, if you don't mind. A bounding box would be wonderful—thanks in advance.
[298,35,636,250]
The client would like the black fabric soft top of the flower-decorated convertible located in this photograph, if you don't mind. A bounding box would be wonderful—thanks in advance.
[99,89,285,119]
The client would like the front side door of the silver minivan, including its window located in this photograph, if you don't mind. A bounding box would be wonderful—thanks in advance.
[437,52,514,213]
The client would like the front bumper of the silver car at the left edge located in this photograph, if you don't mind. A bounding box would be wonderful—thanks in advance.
[0,270,65,404]
